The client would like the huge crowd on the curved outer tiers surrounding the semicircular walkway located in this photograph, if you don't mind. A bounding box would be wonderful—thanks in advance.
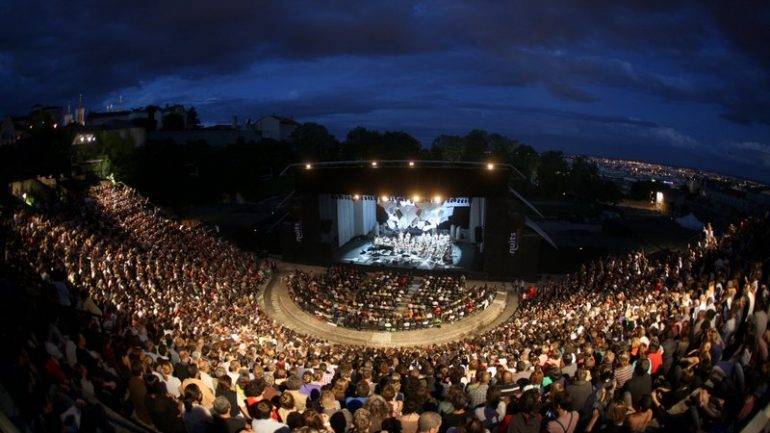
[0,181,770,433]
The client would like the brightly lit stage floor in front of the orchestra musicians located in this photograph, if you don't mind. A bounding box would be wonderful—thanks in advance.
[334,236,476,270]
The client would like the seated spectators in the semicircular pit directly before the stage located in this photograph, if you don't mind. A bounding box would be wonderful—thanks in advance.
[285,266,496,331]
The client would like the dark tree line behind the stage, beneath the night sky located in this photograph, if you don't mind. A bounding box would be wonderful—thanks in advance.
[0,119,621,206]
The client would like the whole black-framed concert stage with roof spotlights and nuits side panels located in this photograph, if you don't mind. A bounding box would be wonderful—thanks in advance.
[280,160,537,278]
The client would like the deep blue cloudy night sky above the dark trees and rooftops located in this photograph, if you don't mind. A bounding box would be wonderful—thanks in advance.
[0,0,770,181]
